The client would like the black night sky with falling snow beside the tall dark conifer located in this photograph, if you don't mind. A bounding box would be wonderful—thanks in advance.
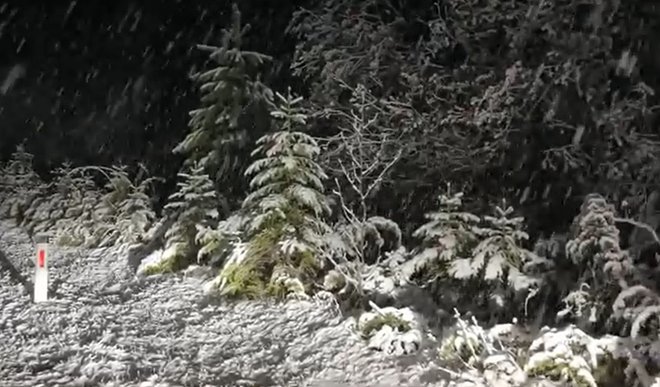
[0,0,302,187]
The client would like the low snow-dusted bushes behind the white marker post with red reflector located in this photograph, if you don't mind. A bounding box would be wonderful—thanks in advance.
[0,149,156,247]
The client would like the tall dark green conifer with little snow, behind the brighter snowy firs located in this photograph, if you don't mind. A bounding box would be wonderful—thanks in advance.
[174,4,272,189]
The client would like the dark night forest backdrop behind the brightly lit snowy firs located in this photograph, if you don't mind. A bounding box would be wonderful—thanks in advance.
[0,0,660,242]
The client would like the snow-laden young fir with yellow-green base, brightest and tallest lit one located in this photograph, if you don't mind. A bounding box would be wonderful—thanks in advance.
[223,93,329,296]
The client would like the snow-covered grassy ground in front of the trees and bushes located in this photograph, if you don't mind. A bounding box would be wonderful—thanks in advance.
[0,222,447,387]
